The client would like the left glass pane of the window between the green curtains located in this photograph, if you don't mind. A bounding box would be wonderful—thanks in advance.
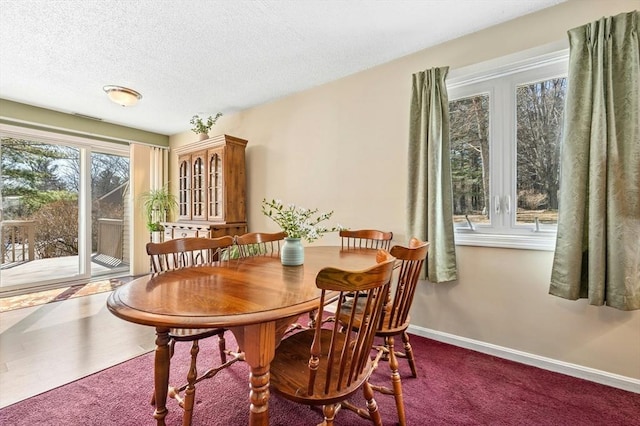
[449,94,489,223]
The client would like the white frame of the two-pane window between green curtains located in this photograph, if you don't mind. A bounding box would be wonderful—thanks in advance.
[447,42,569,250]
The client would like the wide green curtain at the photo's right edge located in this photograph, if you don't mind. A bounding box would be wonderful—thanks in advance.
[549,11,640,310]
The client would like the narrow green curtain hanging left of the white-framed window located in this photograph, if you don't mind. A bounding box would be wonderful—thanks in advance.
[407,67,457,282]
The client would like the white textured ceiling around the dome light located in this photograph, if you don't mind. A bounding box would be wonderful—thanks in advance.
[0,0,565,134]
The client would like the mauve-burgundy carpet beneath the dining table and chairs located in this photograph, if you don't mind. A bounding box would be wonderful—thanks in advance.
[0,333,640,426]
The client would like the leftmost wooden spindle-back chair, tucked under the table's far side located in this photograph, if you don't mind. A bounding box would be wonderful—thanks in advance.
[147,236,243,425]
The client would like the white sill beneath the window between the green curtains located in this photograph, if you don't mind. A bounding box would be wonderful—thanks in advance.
[455,229,556,251]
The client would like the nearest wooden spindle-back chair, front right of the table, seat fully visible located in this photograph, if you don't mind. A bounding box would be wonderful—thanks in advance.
[270,250,395,426]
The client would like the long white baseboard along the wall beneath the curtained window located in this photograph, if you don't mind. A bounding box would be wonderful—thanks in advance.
[407,325,640,393]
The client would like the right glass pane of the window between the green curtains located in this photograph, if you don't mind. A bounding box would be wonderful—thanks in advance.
[516,78,566,224]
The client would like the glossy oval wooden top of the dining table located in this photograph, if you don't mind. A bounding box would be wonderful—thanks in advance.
[107,246,376,328]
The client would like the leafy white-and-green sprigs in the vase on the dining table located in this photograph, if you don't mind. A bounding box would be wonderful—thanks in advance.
[262,199,343,243]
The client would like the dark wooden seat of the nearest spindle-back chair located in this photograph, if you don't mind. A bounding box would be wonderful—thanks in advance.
[271,330,372,405]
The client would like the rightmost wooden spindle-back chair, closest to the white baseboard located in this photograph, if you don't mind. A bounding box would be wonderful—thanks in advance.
[337,238,429,425]
